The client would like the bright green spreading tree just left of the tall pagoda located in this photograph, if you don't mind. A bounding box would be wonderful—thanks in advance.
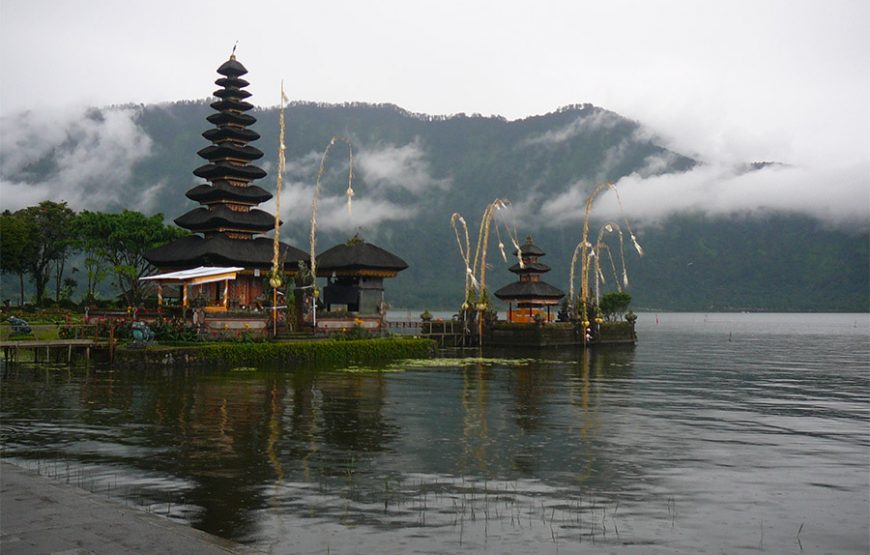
[99,210,186,306]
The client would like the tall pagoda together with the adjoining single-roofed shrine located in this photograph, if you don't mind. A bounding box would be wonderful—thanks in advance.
[131,55,408,338]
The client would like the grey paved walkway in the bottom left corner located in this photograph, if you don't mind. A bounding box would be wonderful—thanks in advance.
[0,463,259,555]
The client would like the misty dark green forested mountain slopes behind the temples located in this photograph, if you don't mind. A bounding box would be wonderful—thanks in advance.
[4,101,870,311]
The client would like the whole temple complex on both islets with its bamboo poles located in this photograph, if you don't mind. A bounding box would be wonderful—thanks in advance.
[68,53,636,356]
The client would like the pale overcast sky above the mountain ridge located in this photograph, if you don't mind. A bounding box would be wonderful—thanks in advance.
[0,0,870,226]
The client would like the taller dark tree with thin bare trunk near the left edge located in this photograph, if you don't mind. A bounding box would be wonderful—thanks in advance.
[16,200,75,304]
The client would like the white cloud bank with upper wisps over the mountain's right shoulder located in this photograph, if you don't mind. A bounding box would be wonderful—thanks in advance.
[517,112,870,229]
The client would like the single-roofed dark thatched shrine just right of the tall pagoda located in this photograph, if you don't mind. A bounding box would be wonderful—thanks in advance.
[316,235,408,329]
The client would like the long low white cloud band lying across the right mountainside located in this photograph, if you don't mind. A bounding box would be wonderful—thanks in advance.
[523,158,870,229]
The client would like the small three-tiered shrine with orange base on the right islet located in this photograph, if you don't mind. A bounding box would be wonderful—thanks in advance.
[495,237,565,323]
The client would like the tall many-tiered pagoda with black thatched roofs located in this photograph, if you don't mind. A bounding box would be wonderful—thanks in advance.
[145,55,306,311]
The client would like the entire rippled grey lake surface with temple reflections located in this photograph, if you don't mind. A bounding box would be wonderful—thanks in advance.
[0,313,870,554]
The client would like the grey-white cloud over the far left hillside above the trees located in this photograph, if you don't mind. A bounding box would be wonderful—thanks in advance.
[0,108,155,210]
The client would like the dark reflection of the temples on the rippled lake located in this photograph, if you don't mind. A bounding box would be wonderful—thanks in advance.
[3,350,633,538]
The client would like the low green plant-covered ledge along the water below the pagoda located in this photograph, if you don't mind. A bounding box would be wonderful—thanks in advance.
[114,337,436,367]
